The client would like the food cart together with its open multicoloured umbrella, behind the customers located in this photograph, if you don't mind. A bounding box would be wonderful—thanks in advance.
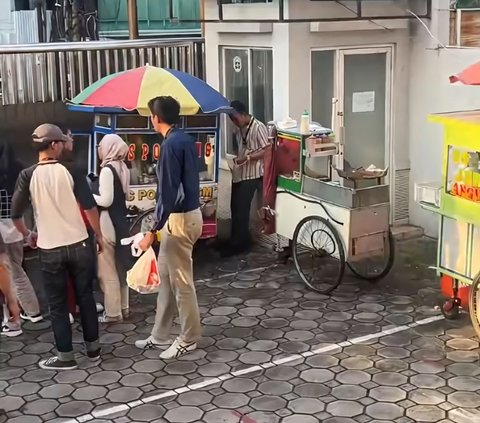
[67,65,230,239]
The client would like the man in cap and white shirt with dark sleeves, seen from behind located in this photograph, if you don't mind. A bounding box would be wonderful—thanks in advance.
[12,123,102,370]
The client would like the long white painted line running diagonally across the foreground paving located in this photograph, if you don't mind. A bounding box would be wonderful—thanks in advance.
[65,314,444,423]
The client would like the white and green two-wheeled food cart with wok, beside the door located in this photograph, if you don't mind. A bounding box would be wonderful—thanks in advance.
[266,125,394,293]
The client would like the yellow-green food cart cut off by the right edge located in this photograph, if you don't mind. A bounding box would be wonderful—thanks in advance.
[415,110,480,336]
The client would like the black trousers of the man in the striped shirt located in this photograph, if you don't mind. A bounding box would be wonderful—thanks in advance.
[230,178,262,248]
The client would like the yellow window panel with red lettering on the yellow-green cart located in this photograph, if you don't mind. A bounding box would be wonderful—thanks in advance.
[445,146,480,202]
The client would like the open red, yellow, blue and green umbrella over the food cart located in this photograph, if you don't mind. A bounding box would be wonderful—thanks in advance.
[71,66,229,116]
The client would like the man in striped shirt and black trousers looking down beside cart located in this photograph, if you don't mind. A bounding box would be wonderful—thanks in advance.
[222,100,268,257]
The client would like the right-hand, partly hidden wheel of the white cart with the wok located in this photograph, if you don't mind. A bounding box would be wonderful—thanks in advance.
[347,231,395,282]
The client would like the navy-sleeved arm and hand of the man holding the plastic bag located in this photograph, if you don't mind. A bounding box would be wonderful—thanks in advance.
[139,146,183,251]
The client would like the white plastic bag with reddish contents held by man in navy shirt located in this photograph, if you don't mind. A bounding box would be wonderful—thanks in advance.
[127,247,160,294]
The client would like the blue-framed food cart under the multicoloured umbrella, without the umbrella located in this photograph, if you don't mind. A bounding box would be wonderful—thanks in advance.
[68,105,220,238]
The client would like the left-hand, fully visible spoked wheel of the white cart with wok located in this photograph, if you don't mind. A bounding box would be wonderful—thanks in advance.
[292,216,345,294]
